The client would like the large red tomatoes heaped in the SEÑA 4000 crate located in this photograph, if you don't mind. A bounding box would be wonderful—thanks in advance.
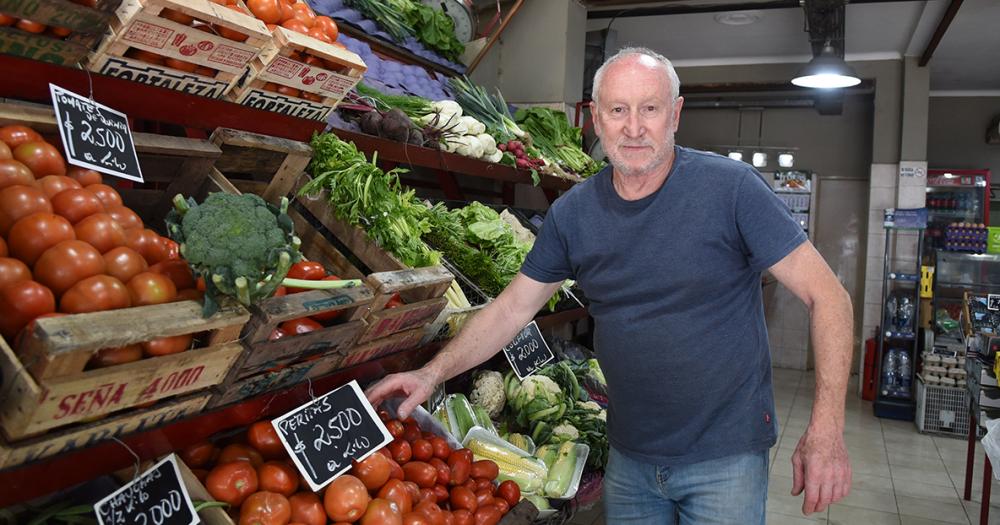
[0,125,202,367]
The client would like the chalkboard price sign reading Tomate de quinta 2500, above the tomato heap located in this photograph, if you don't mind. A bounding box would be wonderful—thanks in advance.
[49,84,142,182]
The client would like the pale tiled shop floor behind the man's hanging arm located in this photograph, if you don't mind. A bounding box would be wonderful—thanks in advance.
[570,369,1000,525]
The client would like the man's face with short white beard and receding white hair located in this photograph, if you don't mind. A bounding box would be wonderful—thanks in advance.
[594,55,684,176]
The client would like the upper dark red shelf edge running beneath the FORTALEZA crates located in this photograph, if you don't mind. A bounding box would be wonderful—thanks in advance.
[0,55,575,200]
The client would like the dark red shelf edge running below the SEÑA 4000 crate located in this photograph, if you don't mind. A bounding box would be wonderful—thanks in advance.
[0,343,440,508]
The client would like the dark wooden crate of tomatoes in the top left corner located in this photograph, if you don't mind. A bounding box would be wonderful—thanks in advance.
[0,0,121,66]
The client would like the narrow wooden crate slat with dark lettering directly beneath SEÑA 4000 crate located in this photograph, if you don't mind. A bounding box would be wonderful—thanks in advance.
[0,392,211,470]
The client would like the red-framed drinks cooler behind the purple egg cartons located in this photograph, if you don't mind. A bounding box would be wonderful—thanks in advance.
[924,169,990,258]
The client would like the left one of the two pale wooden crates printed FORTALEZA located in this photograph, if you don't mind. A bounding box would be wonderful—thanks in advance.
[88,0,271,98]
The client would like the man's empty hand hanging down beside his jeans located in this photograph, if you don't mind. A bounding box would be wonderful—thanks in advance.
[792,426,851,515]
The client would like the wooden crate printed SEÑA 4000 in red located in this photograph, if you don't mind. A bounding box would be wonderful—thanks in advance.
[0,301,250,440]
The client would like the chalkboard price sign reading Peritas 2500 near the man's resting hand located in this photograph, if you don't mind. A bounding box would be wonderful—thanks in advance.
[271,381,392,491]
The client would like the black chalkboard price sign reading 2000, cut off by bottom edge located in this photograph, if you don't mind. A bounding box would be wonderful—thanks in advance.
[94,454,201,525]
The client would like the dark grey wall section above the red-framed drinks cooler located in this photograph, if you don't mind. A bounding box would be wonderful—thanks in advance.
[927,96,1000,226]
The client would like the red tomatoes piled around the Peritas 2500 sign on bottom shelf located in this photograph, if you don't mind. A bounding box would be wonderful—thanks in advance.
[188,411,521,525]
